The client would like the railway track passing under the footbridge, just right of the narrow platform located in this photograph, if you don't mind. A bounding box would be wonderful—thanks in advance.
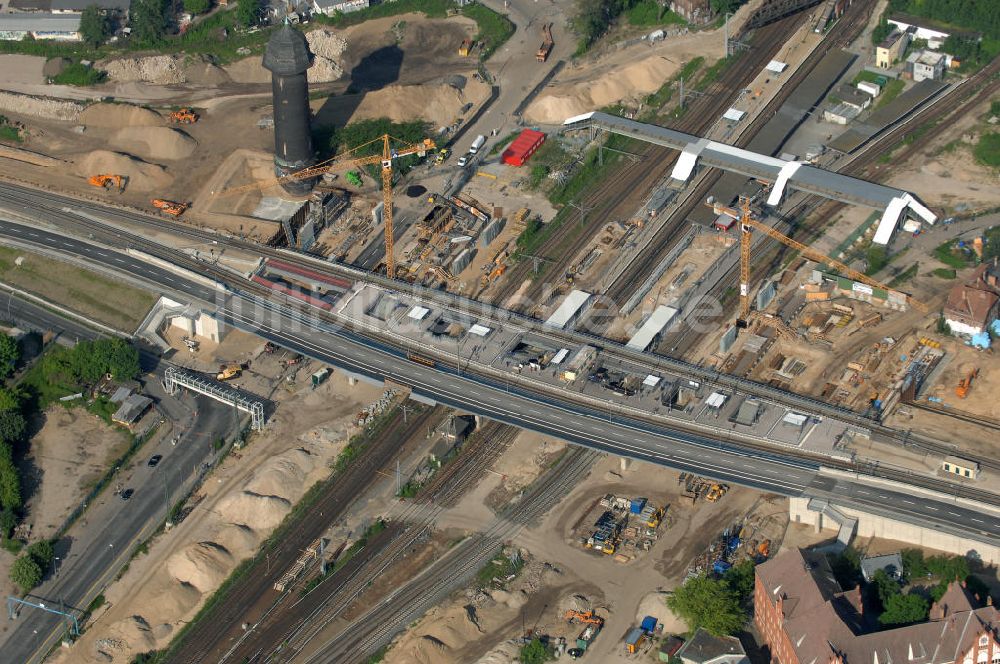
[606,2,874,303]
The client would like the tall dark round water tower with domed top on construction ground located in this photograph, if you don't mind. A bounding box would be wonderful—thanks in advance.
[263,22,316,196]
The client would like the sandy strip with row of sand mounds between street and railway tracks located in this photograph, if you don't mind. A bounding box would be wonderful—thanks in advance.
[50,332,382,664]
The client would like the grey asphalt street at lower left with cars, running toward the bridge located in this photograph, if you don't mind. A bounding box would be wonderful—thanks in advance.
[0,293,236,662]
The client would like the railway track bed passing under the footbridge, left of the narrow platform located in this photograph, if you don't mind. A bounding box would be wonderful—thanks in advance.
[491,15,803,302]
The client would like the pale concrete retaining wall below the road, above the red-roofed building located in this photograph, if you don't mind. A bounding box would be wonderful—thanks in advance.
[788,497,1000,565]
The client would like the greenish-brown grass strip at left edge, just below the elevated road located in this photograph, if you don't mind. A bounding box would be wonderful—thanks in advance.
[0,247,156,330]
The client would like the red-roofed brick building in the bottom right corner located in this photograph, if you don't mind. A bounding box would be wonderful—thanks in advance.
[754,549,1000,664]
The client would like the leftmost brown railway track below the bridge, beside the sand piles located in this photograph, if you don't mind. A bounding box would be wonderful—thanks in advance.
[166,409,440,664]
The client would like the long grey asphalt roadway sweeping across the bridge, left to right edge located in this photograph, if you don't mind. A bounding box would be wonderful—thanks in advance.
[0,224,1000,556]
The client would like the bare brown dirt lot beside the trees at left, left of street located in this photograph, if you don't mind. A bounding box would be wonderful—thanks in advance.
[25,406,129,539]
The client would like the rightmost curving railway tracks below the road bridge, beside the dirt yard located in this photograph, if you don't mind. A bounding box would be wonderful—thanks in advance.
[300,448,600,664]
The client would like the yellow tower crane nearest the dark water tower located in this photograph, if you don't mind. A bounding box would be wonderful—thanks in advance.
[216,134,436,278]
